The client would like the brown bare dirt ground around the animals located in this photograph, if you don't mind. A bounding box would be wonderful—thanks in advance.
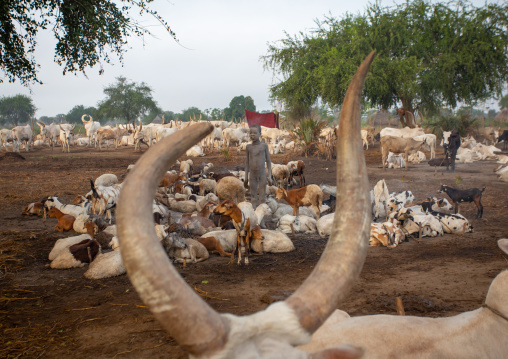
[0,142,508,359]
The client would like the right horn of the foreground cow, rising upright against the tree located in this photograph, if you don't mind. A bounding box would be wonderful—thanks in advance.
[286,51,375,333]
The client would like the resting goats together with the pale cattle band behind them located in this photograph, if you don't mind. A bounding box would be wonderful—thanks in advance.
[1,115,508,277]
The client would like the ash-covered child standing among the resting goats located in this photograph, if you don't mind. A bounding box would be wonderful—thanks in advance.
[244,125,272,209]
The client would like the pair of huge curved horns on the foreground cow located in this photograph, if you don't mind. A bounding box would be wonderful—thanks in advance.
[117,52,374,356]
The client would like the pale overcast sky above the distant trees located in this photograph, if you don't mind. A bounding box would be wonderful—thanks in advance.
[0,0,500,117]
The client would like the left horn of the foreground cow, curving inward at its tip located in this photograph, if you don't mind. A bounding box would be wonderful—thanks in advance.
[117,123,229,354]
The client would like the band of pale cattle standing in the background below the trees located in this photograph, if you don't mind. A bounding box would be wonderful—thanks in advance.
[0,115,508,182]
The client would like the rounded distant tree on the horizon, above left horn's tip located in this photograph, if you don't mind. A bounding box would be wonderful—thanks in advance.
[99,76,157,123]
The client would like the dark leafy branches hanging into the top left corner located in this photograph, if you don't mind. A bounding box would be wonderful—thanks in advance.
[0,0,176,85]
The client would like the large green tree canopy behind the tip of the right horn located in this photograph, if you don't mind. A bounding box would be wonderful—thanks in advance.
[261,0,508,118]
